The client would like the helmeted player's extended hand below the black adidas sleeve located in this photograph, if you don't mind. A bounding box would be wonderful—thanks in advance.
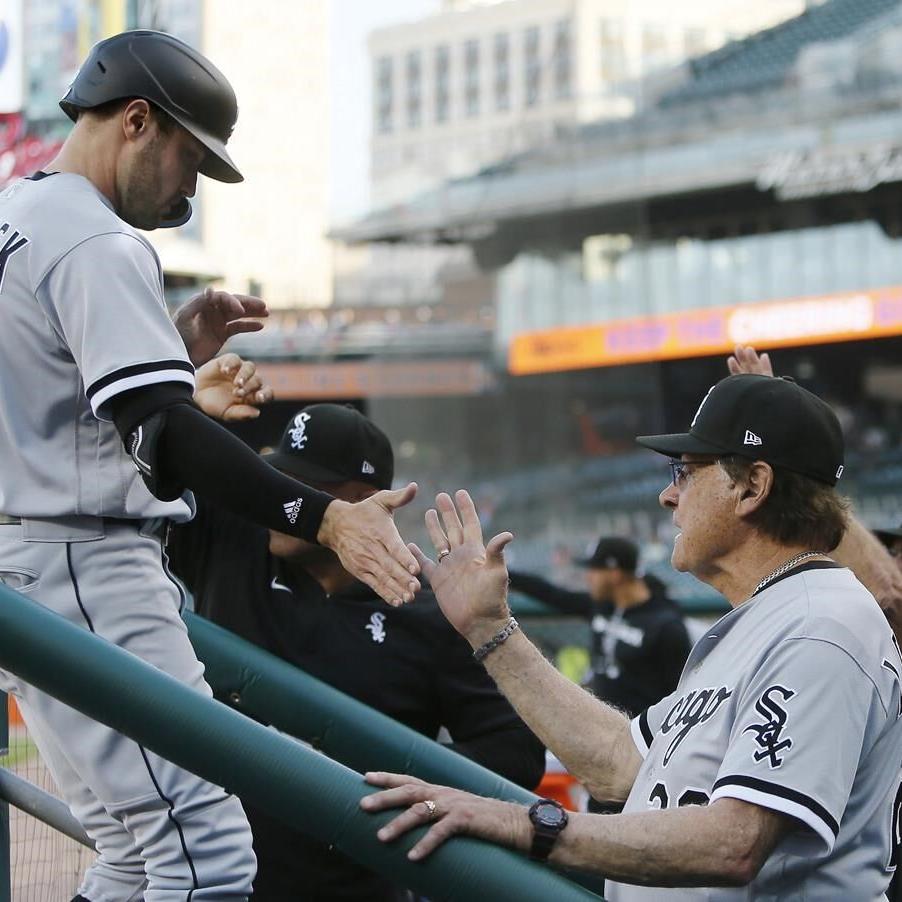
[317,482,420,607]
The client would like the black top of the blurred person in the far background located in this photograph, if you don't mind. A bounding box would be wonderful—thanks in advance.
[510,572,692,717]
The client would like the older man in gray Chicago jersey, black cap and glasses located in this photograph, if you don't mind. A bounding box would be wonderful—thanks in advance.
[362,374,902,902]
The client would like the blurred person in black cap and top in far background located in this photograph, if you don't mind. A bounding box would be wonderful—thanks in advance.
[510,536,691,728]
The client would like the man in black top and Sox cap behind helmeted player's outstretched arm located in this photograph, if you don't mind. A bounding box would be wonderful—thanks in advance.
[174,355,545,902]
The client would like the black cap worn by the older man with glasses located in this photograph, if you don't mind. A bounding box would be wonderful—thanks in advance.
[636,373,844,485]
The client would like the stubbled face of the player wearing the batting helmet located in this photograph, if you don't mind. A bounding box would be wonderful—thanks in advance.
[118,123,204,230]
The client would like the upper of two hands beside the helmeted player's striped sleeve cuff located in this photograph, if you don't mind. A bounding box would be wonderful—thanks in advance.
[172,288,269,366]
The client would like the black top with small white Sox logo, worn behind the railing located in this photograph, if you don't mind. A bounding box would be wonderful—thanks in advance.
[167,505,545,900]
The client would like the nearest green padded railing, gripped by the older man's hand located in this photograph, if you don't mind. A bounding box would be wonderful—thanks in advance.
[0,586,600,902]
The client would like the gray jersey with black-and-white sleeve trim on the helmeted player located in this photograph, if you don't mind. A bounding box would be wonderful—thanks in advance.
[0,173,194,520]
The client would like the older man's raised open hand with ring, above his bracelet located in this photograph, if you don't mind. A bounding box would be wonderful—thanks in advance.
[410,490,513,648]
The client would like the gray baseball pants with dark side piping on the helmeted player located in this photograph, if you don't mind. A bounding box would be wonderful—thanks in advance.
[0,517,256,902]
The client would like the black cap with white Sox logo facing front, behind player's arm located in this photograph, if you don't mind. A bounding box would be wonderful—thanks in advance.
[263,404,395,489]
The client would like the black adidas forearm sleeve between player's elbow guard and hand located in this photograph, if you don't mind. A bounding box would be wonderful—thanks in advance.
[157,404,333,542]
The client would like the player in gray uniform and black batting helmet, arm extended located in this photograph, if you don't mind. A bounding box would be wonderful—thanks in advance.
[0,31,418,902]
